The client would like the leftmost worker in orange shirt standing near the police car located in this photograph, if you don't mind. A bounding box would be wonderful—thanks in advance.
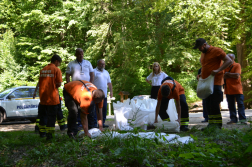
[39,55,62,140]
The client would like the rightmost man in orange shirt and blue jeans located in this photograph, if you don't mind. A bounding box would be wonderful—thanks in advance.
[224,54,247,124]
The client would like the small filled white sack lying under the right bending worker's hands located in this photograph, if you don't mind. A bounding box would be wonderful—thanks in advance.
[153,121,180,132]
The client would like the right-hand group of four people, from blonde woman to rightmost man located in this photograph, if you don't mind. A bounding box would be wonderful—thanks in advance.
[150,38,246,131]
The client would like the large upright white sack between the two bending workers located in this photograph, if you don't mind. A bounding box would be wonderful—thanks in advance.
[113,99,178,130]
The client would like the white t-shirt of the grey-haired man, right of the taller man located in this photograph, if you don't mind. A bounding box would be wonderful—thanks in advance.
[94,67,111,97]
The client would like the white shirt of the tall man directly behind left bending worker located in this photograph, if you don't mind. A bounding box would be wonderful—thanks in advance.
[66,59,94,82]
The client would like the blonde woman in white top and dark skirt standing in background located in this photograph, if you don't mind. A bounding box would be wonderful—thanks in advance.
[146,62,168,99]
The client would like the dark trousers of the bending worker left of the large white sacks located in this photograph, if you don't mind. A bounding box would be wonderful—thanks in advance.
[63,90,95,136]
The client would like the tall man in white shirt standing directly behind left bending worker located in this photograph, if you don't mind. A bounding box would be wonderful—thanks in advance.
[66,48,97,128]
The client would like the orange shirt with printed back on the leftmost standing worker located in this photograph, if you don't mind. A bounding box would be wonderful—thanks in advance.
[39,64,62,105]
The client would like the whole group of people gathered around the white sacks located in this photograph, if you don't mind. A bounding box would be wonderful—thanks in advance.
[38,38,246,140]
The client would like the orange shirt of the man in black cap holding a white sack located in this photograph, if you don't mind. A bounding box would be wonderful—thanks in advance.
[201,46,226,85]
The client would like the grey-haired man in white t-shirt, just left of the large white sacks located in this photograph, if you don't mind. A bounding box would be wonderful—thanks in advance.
[94,59,113,128]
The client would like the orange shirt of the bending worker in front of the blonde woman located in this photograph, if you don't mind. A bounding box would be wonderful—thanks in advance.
[158,80,185,101]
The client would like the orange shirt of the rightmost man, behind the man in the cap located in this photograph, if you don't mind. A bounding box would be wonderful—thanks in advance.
[224,62,243,95]
